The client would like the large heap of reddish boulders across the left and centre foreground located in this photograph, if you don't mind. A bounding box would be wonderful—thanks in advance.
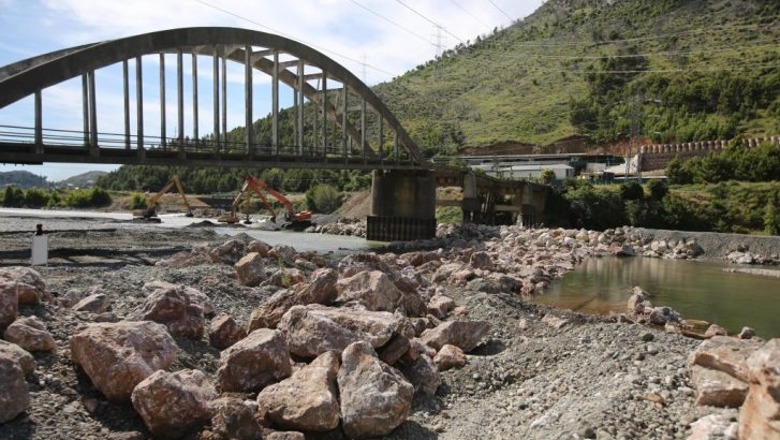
[0,238,492,438]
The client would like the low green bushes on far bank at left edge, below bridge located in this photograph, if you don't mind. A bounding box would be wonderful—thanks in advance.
[0,186,111,209]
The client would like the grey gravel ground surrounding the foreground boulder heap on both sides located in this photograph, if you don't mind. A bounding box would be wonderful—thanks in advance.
[0,211,736,440]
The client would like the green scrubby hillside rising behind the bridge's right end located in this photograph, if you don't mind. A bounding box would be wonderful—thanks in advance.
[375,0,780,155]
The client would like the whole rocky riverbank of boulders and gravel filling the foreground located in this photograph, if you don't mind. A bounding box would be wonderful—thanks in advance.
[0,217,777,440]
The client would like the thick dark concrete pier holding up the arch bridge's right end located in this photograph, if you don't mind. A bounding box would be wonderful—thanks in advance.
[366,170,436,241]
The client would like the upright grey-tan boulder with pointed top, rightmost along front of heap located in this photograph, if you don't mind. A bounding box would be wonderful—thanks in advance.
[337,341,414,439]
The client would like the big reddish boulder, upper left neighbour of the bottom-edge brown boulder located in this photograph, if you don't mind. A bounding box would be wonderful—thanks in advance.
[70,321,179,402]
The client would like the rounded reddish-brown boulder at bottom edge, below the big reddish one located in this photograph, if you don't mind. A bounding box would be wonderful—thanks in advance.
[131,370,217,438]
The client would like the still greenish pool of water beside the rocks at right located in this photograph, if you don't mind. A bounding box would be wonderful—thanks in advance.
[534,257,780,338]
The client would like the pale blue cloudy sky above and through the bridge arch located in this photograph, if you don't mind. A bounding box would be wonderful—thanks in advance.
[0,0,544,181]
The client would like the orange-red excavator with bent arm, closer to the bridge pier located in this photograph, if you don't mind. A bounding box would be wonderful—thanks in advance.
[219,175,312,230]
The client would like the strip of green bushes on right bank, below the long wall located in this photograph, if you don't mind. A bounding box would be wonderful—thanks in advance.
[546,180,780,235]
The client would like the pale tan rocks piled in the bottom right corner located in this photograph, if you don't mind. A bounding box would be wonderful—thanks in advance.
[688,336,780,439]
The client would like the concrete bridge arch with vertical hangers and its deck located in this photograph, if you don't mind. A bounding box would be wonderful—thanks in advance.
[0,27,428,170]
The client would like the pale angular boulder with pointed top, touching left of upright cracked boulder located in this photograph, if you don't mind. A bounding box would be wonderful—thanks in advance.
[257,351,340,432]
